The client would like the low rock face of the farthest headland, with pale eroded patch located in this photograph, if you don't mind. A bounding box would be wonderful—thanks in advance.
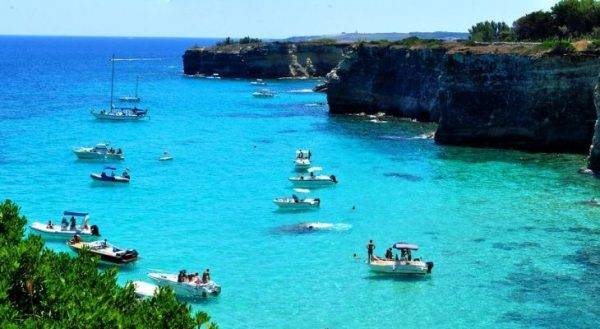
[183,42,348,79]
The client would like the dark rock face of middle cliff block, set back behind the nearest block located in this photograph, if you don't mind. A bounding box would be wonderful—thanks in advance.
[325,44,446,121]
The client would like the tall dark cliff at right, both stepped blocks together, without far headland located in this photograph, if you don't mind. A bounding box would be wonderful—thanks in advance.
[324,42,600,153]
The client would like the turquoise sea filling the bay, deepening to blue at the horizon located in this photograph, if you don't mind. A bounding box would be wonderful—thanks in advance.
[0,37,600,328]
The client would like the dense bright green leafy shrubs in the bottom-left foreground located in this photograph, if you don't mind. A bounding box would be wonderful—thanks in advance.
[0,200,216,328]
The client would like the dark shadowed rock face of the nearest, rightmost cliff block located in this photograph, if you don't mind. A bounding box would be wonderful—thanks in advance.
[435,53,600,153]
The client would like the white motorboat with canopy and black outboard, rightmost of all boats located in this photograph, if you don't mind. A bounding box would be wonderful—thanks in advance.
[367,242,433,275]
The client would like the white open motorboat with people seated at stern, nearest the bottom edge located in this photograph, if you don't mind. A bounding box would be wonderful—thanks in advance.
[148,271,221,298]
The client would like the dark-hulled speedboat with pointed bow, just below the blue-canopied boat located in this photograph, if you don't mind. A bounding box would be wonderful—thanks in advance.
[67,236,138,265]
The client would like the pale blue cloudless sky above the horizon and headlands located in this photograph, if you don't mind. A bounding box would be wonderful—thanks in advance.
[0,0,556,38]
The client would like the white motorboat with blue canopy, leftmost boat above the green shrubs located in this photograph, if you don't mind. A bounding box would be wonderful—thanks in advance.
[29,211,100,240]
